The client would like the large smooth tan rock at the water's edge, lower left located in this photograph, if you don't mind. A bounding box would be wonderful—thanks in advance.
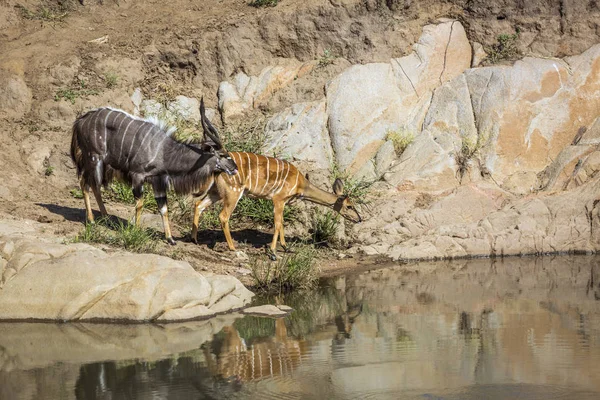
[0,223,253,321]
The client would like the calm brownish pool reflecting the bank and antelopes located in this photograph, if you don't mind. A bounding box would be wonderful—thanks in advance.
[0,257,600,400]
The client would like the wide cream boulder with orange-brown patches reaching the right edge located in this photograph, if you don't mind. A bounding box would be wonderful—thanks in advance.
[385,45,600,192]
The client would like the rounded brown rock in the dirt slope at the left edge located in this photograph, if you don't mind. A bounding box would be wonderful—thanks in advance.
[0,70,32,119]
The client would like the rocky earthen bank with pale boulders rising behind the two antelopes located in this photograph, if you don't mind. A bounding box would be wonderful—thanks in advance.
[0,0,600,264]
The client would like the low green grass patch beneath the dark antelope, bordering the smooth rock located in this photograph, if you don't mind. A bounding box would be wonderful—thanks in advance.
[74,218,158,253]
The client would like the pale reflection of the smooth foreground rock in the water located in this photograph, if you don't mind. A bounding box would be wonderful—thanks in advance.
[0,314,239,370]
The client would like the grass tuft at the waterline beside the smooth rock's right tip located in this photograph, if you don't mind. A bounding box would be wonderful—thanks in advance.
[250,245,318,293]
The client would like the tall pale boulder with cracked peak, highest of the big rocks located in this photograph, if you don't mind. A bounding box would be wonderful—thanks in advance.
[326,21,471,173]
